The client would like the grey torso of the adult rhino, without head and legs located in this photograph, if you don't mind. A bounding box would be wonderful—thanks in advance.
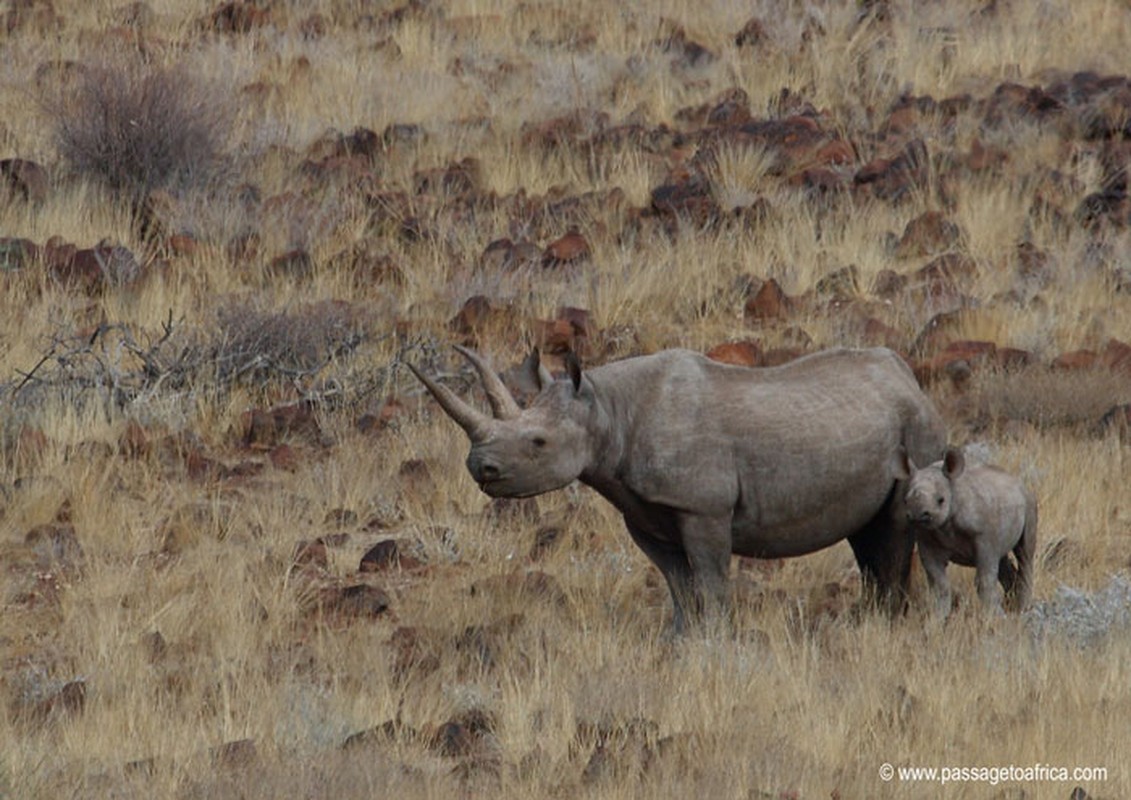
[594,349,944,556]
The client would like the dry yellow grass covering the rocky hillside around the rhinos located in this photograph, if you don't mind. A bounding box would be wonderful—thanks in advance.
[0,0,1131,800]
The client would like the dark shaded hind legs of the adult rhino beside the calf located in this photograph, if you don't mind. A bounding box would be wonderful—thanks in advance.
[848,484,915,617]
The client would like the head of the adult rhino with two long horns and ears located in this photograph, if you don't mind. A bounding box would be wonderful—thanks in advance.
[408,346,594,497]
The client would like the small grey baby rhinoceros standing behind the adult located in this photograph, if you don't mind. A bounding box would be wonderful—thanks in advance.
[897,447,1037,616]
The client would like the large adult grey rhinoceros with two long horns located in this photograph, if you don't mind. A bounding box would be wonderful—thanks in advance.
[412,349,946,631]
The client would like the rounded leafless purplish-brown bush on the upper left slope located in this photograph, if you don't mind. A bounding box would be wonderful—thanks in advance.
[49,63,231,200]
